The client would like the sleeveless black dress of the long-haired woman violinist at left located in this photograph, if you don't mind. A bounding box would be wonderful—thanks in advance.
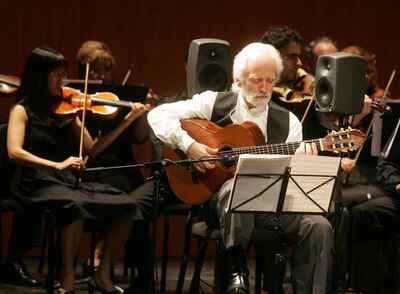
[11,110,143,227]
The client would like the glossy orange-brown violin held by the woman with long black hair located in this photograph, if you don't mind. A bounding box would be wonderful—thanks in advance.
[51,87,137,119]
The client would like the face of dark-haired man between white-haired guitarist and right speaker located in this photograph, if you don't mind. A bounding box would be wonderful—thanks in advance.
[280,41,302,82]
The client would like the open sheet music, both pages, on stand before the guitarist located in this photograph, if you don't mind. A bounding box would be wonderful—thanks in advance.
[230,155,340,213]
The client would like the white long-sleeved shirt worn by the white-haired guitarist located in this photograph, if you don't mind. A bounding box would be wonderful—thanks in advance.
[147,91,302,153]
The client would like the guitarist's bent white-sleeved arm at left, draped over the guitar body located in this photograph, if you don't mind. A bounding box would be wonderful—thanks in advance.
[147,91,217,153]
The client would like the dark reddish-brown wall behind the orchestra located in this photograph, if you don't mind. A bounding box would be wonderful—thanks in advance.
[0,0,400,254]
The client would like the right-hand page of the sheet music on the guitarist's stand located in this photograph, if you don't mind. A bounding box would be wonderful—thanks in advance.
[283,155,340,213]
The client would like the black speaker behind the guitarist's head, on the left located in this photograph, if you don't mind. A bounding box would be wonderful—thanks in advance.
[187,38,231,97]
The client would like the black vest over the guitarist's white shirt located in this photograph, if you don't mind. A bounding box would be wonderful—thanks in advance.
[211,92,289,144]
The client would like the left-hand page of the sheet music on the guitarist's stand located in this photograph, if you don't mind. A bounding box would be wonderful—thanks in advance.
[230,154,292,212]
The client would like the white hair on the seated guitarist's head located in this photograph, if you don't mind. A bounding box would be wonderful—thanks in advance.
[232,43,283,90]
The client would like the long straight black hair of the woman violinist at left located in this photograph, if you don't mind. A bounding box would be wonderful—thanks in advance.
[17,46,68,121]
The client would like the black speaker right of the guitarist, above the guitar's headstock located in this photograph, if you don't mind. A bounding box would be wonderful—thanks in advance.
[315,52,365,115]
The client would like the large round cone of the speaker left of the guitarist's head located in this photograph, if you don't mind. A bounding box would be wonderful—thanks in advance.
[199,64,229,91]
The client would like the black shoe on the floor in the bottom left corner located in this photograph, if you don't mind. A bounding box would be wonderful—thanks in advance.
[0,261,40,287]
